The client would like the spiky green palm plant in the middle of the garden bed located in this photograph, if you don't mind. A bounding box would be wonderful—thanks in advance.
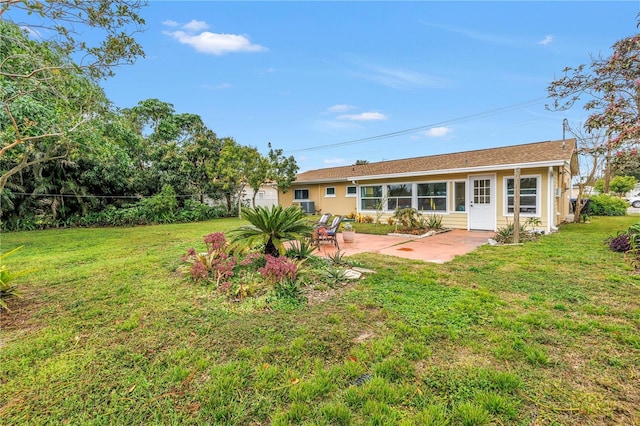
[230,206,312,257]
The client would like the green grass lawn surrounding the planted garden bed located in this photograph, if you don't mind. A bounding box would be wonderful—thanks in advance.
[0,217,640,425]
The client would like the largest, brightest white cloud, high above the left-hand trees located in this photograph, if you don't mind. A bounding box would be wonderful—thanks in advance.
[163,19,268,56]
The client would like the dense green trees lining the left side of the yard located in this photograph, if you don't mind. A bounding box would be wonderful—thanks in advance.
[0,0,298,230]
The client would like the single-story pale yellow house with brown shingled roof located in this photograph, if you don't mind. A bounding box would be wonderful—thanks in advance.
[279,139,577,232]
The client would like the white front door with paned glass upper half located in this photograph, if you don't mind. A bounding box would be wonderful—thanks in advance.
[469,176,496,231]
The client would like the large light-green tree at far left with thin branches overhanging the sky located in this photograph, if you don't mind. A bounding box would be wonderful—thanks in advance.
[0,0,144,192]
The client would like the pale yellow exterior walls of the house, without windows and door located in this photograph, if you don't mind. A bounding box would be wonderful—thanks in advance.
[280,167,571,231]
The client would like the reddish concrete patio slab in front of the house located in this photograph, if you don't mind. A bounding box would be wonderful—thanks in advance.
[318,229,495,263]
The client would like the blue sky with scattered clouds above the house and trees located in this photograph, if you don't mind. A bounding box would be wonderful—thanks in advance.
[103,1,640,171]
